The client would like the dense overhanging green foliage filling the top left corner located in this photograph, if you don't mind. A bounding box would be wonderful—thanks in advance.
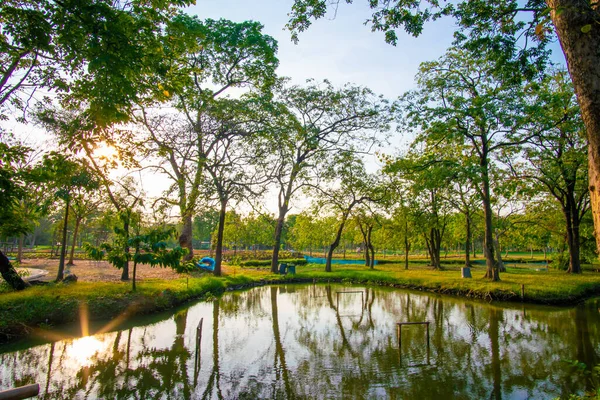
[0,0,191,125]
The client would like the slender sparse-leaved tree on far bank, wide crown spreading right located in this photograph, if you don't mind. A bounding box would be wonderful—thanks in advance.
[271,81,390,273]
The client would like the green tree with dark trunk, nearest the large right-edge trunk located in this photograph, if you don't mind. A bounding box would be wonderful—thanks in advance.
[508,71,590,273]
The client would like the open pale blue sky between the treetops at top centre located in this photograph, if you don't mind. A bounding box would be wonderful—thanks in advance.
[187,0,564,99]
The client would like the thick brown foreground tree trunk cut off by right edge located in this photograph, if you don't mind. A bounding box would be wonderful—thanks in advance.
[546,0,600,260]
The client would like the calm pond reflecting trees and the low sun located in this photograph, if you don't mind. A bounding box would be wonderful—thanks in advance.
[0,285,600,399]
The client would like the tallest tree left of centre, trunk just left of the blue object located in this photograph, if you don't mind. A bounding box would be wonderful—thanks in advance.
[138,14,278,258]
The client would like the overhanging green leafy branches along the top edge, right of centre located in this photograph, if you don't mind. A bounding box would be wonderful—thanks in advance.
[287,0,552,81]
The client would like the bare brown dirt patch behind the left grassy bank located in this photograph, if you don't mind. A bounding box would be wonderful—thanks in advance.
[20,259,199,282]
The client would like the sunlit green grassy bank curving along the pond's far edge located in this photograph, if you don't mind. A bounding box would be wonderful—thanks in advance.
[0,264,600,342]
